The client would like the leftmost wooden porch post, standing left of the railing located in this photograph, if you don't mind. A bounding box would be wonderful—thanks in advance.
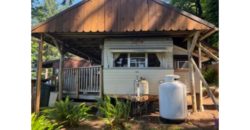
[35,34,43,113]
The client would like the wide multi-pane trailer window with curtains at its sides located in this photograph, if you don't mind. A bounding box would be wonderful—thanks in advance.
[113,53,163,68]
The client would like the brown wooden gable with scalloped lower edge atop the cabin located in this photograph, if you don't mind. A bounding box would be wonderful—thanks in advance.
[32,0,216,33]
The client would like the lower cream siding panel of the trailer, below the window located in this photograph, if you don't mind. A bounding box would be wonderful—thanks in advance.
[103,68,174,95]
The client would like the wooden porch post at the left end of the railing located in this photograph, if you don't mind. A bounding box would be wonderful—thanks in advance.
[58,49,64,100]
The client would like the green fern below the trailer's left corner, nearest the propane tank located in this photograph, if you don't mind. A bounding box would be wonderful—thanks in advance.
[98,96,131,128]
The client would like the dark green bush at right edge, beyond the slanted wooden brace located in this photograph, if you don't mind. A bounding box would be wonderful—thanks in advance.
[203,67,219,86]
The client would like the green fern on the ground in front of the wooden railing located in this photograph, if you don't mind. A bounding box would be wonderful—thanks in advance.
[43,97,90,126]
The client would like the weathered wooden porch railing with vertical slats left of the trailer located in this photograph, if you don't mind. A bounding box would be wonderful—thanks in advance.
[63,66,102,98]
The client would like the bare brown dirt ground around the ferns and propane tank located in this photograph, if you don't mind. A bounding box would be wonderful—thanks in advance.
[62,97,219,130]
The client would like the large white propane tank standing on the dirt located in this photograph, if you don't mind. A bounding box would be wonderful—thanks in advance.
[159,75,187,120]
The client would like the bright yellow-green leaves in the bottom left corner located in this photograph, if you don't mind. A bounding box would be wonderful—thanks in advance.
[31,113,62,130]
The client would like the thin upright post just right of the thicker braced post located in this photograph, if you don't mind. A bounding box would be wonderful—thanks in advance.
[198,42,204,111]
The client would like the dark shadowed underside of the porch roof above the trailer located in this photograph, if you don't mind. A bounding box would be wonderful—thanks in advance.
[32,31,199,64]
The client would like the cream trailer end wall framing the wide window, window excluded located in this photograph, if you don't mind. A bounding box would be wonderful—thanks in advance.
[103,38,174,95]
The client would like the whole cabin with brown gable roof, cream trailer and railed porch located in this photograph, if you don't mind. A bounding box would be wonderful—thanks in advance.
[32,0,218,110]
